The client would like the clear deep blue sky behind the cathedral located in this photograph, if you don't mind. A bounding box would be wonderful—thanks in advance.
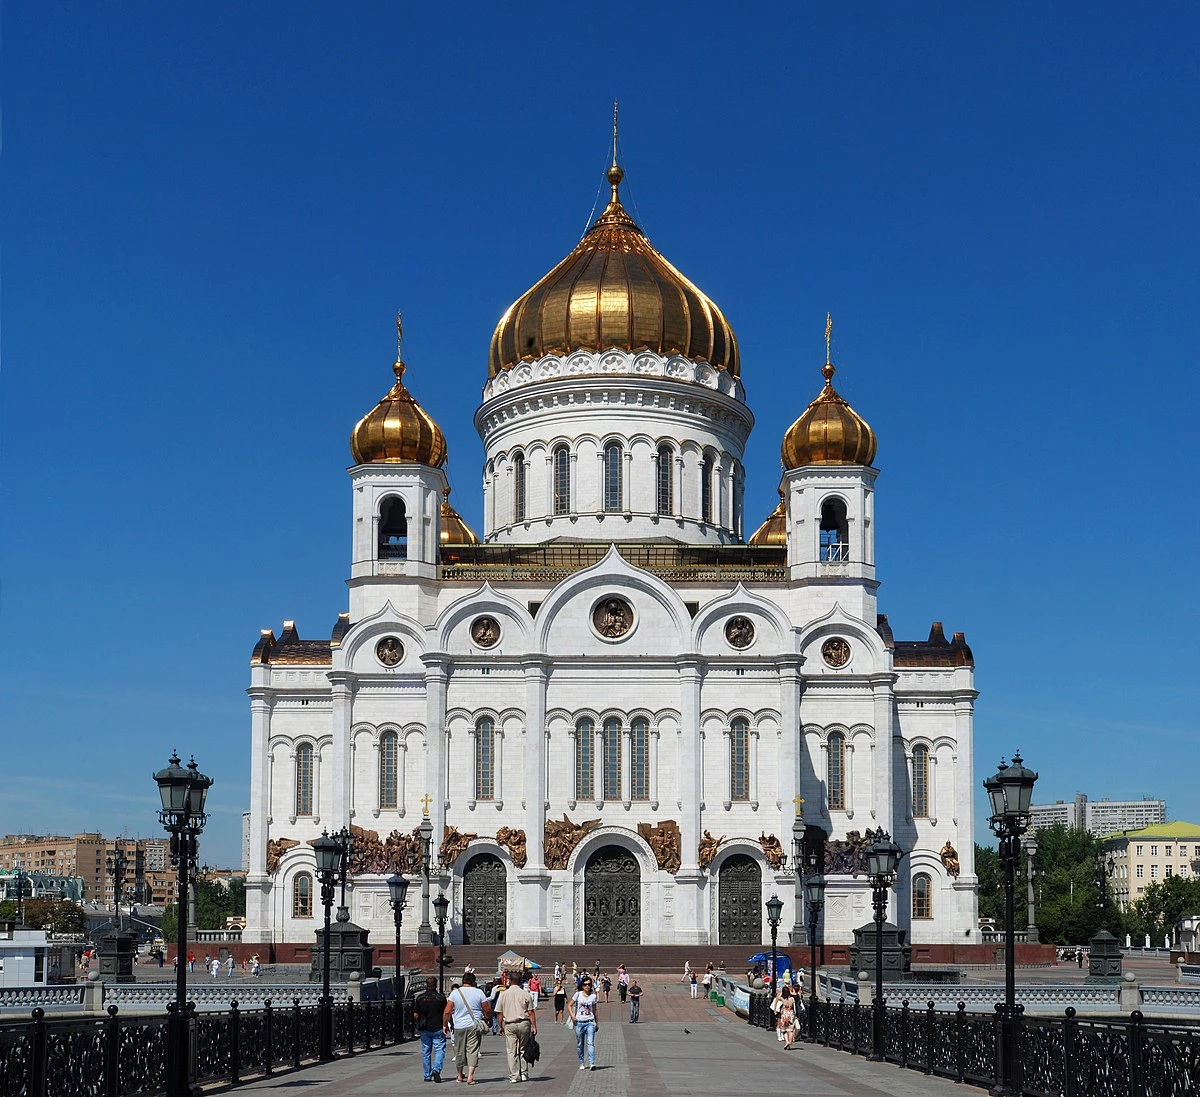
[0,0,1200,864]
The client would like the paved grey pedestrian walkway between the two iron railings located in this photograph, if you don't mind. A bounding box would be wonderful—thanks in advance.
[229,978,969,1097]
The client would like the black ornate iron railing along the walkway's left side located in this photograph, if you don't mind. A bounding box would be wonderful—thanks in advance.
[0,999,415,1097]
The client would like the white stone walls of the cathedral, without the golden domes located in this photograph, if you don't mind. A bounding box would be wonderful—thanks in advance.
[245,175,979,946]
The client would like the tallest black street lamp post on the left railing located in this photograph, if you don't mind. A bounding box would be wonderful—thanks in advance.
[154,754,212,1097]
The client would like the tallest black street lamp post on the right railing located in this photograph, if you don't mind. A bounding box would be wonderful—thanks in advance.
[983,751,1038,1097]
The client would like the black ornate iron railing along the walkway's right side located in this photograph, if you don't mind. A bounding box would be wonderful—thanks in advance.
[749,991,1200,1097]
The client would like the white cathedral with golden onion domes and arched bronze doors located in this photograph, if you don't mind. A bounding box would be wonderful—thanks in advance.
[244,157,979,946]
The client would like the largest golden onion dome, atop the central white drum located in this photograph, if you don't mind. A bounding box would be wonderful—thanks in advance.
[487,163,742,377]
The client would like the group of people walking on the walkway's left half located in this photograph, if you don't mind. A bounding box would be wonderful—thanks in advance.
[413,964,644,1085]
